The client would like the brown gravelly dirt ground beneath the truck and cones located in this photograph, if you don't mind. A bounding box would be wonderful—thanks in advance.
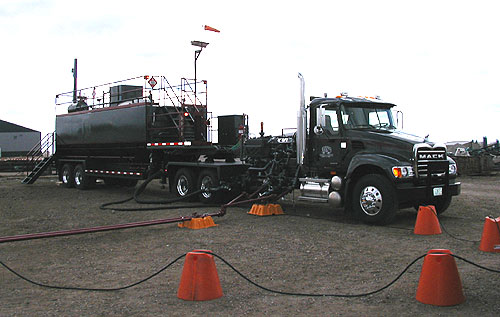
[0,175,500,316]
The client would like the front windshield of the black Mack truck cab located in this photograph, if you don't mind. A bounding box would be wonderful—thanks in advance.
[341,106,396,130]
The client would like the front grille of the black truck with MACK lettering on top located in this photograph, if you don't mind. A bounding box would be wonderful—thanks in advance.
[415,145,448,178]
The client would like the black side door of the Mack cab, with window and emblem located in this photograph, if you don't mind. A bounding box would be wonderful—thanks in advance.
[309,104,346,177]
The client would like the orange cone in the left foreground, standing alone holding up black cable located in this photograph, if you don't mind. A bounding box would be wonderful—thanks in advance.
[177,250,222,301]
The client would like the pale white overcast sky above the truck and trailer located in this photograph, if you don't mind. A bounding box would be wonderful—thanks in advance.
[0,0,500,142]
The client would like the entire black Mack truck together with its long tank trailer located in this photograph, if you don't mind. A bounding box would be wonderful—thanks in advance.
[27,74,460,224]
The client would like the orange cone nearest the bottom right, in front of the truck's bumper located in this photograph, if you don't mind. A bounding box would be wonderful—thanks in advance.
[417,249,465,306]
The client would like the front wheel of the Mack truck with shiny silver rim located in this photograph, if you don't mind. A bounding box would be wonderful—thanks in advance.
[352,174,398,224]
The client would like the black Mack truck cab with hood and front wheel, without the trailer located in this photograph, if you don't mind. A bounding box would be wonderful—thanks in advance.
[297,81,460,224]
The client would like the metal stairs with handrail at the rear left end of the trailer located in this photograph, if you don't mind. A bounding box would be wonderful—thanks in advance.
[23,132,55,184]
